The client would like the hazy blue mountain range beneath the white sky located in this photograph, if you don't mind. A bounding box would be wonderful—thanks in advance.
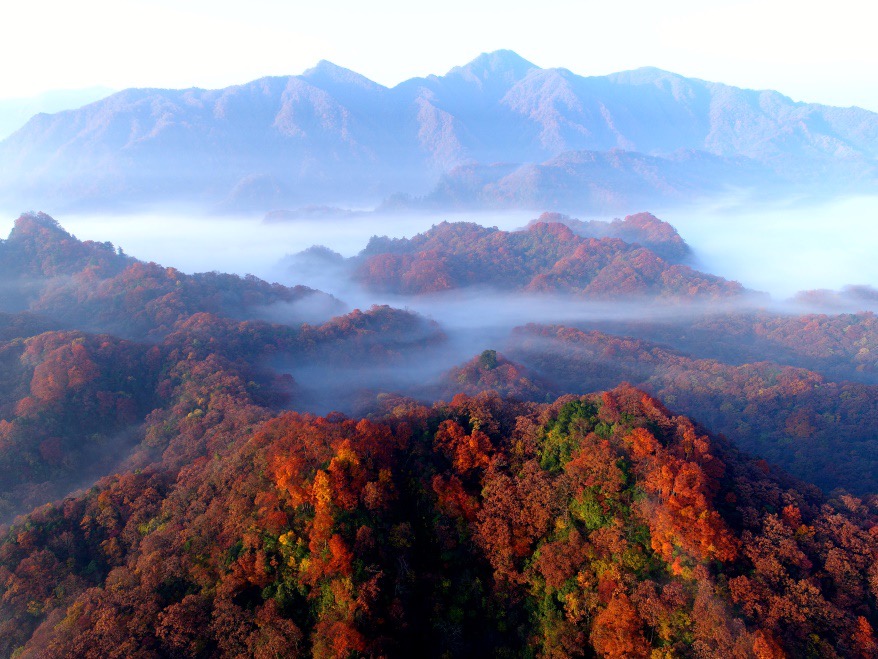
[0,51,878,212]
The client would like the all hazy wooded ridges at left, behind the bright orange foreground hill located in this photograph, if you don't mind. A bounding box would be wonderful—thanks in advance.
[0,214,444,522]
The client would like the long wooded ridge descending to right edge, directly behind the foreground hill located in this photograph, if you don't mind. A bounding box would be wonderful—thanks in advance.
[508,325,878,493]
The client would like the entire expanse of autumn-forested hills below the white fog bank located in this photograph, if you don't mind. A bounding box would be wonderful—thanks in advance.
[0,213,878,659]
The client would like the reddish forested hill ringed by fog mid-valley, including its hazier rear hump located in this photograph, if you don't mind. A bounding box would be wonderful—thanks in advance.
[285,213,752,301]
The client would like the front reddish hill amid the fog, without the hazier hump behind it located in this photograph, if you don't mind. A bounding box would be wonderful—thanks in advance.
[355,222,744,299]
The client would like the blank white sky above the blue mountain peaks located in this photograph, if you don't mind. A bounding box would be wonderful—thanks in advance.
[0,0,878,111]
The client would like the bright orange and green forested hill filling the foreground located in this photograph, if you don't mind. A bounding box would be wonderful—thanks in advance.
[0,387,878,657]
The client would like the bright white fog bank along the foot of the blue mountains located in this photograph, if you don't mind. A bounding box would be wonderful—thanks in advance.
[0,196,878,300]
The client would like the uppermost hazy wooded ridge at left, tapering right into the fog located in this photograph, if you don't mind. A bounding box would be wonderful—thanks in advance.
[0,213,341,338]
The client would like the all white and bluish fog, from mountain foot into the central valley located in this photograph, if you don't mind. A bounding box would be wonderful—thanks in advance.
[0,197,878,413]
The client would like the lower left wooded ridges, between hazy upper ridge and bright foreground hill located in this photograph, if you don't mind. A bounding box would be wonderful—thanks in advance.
[0,307,444,522]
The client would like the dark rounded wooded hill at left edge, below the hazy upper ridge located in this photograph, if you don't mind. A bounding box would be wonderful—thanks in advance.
[0,332,161,520]
